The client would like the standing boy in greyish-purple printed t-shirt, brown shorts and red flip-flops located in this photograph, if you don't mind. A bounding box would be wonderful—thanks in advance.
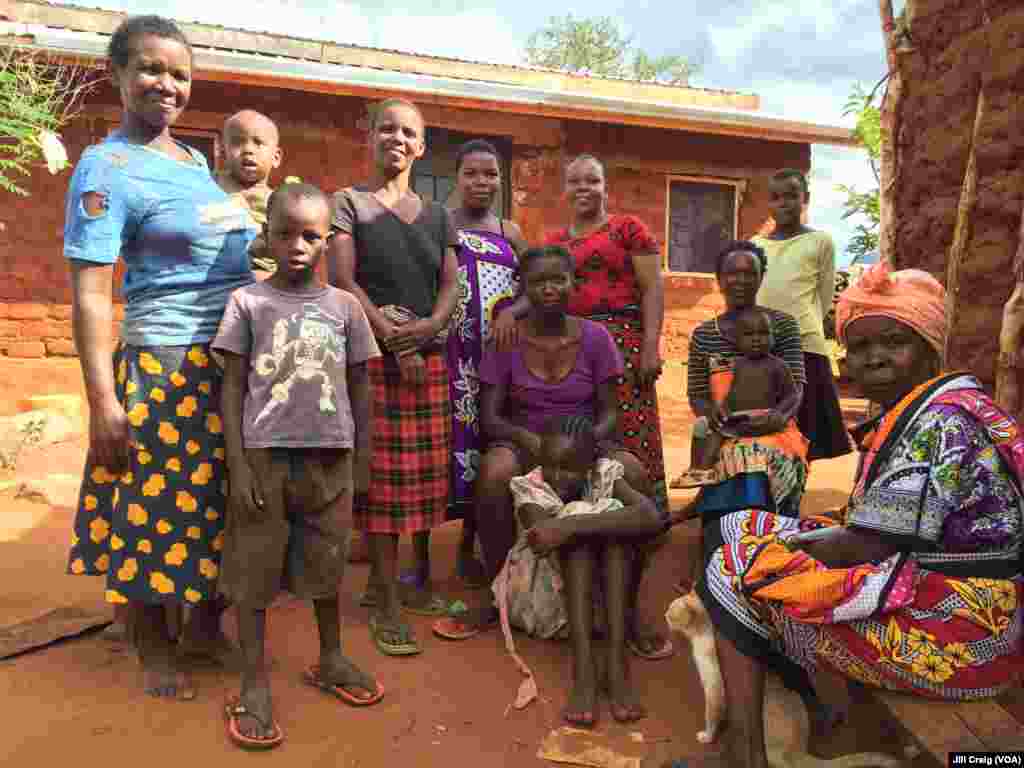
[210,184,383,749]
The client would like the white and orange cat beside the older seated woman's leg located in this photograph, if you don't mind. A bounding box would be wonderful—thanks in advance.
[665,591,903,768]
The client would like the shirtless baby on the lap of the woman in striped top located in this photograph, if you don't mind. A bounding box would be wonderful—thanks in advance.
[680,307,795,487]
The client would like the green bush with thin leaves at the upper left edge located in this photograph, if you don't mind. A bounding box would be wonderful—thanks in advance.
[0,46,99,197]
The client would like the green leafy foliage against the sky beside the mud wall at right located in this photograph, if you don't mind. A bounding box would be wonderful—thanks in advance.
[838,81,885,264]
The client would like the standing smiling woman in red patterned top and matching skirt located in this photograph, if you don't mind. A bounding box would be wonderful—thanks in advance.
[546,155,671,657]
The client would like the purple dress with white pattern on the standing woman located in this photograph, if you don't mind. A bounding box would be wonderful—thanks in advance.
[447,229,519,519]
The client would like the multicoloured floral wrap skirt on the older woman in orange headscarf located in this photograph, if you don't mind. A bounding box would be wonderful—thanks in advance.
[696,511,1024,699]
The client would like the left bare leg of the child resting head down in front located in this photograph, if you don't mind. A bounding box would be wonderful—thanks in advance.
[560,542,597,728]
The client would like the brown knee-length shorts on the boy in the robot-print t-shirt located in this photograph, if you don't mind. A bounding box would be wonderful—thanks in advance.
[220,449,353,608]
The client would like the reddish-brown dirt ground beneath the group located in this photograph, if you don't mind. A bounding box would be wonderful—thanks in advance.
[0,365,901,768]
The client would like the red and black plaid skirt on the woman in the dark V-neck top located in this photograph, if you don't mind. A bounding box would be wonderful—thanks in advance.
[353,350,452,534]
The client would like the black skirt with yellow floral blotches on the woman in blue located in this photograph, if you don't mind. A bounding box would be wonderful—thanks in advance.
[68,344,226,603]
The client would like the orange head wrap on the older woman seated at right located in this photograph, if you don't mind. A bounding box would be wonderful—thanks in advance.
[836,261,948,359]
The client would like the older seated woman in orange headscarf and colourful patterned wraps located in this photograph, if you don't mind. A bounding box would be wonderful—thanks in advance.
[663,263,1024,767]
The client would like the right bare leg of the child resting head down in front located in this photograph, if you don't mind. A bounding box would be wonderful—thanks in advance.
[604,539,646,723]
